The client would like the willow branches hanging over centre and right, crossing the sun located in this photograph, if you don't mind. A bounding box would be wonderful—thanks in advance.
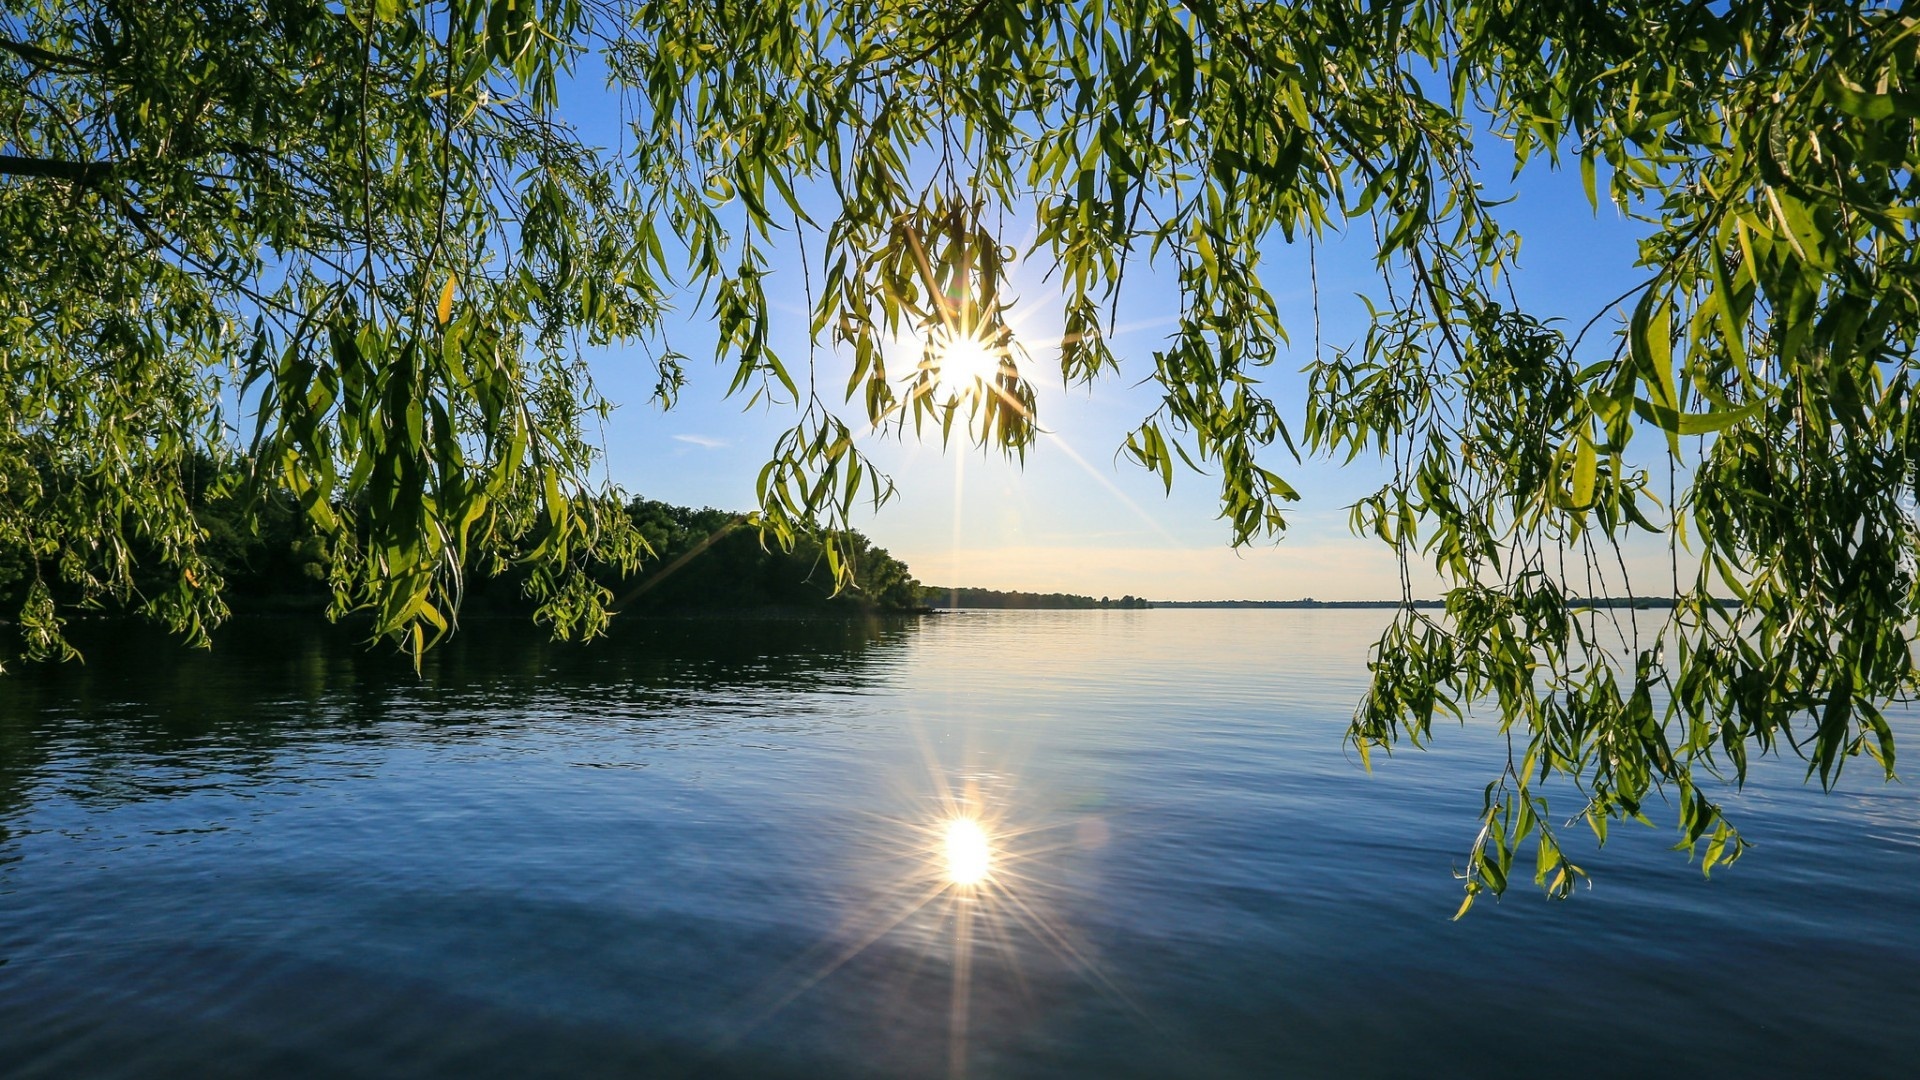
[614,0,1920,903]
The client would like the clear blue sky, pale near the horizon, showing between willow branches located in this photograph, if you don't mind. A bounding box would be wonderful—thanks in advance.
[576,78,1667,600]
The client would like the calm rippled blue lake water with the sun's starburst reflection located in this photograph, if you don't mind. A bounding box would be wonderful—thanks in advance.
[0,611,1920,1076]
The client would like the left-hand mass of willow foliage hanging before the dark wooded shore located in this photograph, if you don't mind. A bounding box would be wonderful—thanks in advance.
[0,0,674,655]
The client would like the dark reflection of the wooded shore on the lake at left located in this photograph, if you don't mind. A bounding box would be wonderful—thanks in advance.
[0,619,916,818]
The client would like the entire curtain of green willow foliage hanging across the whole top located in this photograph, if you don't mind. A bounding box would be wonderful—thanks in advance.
[0,0,1920,903]
